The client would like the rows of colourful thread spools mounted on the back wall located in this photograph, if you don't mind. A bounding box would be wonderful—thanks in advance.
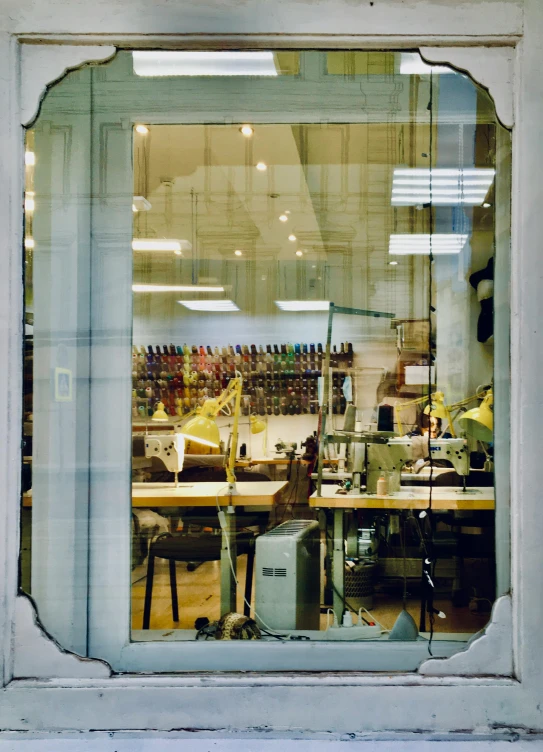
[132,343,354,419]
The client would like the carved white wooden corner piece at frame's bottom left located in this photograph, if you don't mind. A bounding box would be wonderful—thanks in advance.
[13,595,111,679]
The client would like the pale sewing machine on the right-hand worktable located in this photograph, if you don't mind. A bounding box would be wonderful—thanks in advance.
[360,436,469,494]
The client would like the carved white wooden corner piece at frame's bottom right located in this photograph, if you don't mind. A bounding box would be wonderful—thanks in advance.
[419,595,513,676]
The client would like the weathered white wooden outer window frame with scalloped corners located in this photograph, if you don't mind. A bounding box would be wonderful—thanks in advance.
[0,0,543,733]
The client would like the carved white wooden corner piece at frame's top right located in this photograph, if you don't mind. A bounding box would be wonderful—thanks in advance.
[420,47,515,128]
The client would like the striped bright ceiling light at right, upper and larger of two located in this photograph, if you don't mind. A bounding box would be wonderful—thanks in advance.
[392,167,496,206]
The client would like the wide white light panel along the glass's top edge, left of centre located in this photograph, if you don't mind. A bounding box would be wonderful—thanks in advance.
[132,50,278,76]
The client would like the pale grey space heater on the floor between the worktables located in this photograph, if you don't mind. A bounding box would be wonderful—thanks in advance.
[255,520,320,629]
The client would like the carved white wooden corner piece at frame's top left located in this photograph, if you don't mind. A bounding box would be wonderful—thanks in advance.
[21,44,115,125]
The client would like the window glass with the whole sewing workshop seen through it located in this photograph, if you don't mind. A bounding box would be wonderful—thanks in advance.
[20,50,511,647]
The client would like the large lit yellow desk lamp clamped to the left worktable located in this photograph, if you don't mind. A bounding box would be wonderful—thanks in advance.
[179,371,265,494]
